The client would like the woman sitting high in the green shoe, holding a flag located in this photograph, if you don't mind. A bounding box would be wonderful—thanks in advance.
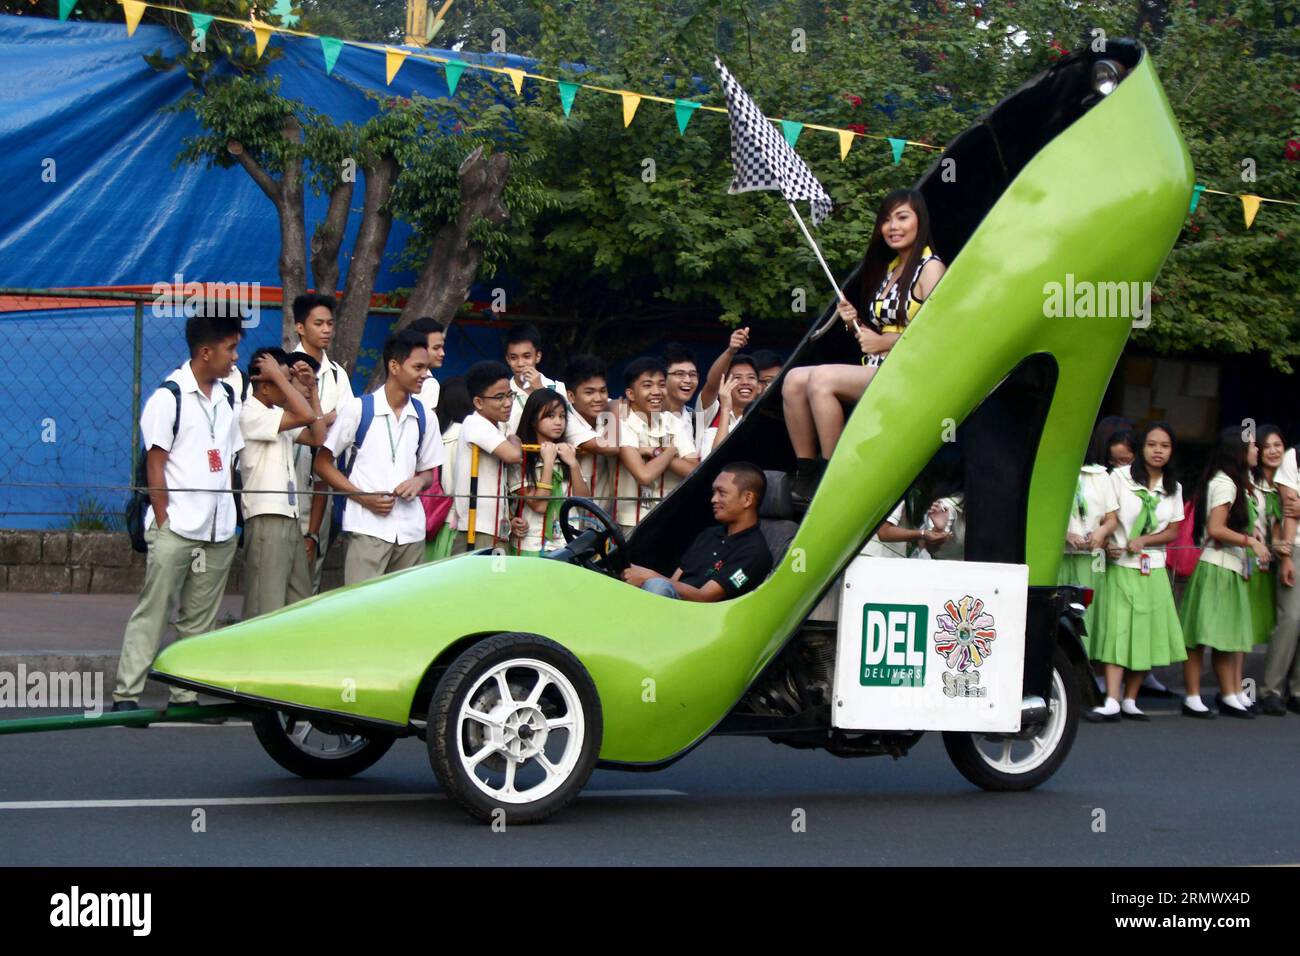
[781,189,945,506]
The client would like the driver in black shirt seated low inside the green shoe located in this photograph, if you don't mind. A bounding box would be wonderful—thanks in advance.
[623,462,772,602]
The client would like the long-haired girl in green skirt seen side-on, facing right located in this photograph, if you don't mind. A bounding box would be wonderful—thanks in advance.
[1179,427,1269,718]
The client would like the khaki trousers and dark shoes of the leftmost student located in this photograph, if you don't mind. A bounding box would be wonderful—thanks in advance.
[113,525,235,704]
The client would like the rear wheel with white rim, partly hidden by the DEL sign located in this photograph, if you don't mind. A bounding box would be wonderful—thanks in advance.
[944,646,1080,791]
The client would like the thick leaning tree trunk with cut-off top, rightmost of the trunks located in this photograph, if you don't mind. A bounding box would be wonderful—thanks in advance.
[371,147,510,388]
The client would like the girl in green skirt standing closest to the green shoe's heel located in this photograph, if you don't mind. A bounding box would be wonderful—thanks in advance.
[1057,429,1119,661]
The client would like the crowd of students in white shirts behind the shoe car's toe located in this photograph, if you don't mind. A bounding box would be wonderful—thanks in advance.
[113,295,783,710]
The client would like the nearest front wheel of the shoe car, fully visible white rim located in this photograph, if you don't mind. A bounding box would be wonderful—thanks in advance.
[428,633,602,823]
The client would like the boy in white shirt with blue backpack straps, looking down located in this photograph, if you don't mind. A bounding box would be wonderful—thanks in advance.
[316,329,443,584]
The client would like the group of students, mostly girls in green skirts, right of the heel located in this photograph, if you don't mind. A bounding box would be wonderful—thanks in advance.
[1060,418,1300,722]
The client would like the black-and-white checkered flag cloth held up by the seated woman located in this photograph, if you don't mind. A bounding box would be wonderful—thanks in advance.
[714,57,831,226]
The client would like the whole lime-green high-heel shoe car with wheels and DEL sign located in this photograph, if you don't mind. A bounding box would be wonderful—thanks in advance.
[153,40,1193,822]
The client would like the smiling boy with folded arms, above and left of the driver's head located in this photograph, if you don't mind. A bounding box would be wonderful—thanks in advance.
[615,358,699,535]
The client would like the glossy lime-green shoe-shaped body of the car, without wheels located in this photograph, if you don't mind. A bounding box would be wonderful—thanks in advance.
[155,44,1193,765]
